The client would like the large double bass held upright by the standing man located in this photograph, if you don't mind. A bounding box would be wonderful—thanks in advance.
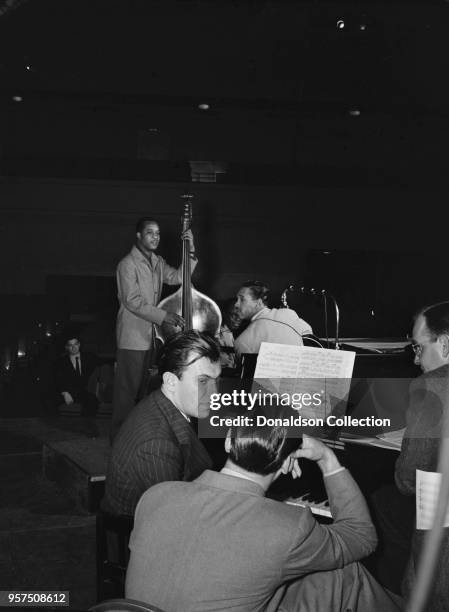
[157,195,222,342]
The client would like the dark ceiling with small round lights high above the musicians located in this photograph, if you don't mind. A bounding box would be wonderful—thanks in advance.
[0,0,449,186]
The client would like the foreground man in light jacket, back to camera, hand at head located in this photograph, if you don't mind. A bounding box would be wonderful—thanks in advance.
[125,427,400,612]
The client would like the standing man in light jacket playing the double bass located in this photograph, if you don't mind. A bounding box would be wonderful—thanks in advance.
[110,217,198,441]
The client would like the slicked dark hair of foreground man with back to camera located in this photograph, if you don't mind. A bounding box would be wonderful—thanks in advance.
[229,426,301,476]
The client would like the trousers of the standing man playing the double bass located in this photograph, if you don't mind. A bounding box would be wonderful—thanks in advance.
[110,349,148,442]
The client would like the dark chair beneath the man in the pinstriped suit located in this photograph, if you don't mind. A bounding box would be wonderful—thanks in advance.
[96,511,134,601]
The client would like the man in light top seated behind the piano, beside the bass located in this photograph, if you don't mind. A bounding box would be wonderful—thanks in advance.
[235,281,312,355]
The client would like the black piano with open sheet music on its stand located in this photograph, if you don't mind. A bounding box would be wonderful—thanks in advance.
[214,338,420,522]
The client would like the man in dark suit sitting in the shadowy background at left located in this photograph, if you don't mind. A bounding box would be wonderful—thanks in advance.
[54,334,99,418]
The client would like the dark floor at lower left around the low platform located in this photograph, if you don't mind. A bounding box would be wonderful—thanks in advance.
[0,415,109,610]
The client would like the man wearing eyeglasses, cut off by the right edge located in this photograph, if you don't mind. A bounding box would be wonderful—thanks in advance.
[373,301,449,611]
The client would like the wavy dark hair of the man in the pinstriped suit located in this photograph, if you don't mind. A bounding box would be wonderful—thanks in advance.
[159,329,220,378]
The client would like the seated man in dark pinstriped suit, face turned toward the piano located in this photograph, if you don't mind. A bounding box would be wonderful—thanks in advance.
[103,330,221,515]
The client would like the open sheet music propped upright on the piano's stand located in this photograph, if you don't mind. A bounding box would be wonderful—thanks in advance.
[254,342,355,418]
